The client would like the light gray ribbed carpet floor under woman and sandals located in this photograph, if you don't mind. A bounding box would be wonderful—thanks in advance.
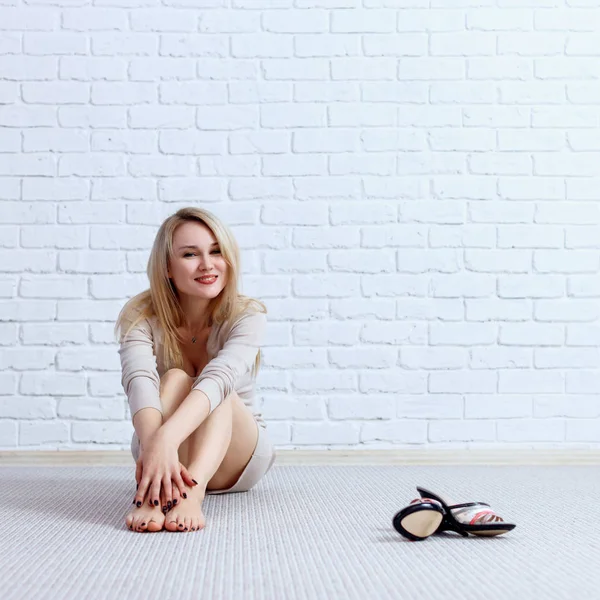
[0,465,600,600]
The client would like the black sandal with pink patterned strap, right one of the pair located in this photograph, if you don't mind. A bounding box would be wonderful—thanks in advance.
[417,486,516,537]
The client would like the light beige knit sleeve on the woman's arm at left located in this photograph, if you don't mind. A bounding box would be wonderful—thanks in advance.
[119,319,163,422]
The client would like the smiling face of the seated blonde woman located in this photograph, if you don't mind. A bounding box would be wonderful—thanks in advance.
[169,221,227,300]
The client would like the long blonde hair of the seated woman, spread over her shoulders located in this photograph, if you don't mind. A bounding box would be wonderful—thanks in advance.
[114,207,267,374]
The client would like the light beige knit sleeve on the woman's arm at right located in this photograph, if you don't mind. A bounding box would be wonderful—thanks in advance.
[192,312,267,414]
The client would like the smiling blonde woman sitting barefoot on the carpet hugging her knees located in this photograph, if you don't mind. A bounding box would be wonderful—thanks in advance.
[115,207,275,532]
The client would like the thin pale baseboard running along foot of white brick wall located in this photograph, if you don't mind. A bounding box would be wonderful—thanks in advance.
[0,449,600,467]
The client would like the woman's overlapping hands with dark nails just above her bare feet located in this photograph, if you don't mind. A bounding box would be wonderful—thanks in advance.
[134,430,196,506]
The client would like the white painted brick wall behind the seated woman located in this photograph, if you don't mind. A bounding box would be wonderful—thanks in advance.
[0,0,600,450]
